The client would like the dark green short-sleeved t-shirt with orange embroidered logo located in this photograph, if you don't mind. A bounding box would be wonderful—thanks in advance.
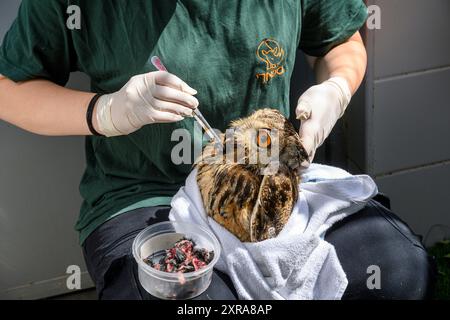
[0,0,367,242]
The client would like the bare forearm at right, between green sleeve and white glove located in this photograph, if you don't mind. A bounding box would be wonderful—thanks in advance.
[308,32,367,94]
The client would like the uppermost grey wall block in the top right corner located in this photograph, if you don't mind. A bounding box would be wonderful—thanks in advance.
[372,0,450,79]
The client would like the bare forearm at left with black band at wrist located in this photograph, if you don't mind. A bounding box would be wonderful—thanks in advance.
[0,75,95,136]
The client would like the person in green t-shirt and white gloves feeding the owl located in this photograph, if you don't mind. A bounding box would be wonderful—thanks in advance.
[0,0,430,298]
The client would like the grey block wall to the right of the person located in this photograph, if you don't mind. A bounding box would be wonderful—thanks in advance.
[347,0,450,240]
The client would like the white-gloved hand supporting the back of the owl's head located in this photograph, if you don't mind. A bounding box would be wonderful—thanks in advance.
[296,77,352,167]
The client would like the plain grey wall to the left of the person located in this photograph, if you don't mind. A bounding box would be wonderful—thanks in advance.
[0,0,91,299]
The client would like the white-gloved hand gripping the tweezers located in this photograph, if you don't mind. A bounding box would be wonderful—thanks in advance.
[95,71,198,137]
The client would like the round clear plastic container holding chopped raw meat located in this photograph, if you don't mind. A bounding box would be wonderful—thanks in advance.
[132,221,221,300]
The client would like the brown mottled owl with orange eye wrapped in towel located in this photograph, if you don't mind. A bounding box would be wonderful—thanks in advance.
[195,109,307,242]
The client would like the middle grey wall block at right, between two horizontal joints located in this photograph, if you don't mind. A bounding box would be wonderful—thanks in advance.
[372,68,450,175]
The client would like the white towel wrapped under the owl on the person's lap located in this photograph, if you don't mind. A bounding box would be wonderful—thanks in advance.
[170,164,378,300]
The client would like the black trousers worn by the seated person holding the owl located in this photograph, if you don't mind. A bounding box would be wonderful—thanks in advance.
[83,200,435,300]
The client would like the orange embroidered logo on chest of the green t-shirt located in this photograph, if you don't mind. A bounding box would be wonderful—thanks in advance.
[256,39,286,84]
